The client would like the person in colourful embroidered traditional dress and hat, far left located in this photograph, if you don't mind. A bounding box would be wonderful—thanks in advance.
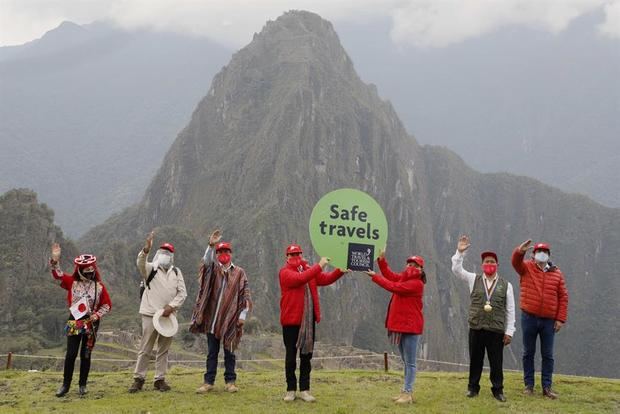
[50,243,112,397]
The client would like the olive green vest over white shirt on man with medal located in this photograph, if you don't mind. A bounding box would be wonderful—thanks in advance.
[469,275,508,333]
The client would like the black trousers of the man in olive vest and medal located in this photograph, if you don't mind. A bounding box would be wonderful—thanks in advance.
[467,329,504,394]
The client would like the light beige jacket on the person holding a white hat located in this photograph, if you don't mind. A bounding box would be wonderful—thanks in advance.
[136,250,187,316]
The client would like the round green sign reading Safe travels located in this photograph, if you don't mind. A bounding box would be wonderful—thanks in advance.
[309,188,388,271]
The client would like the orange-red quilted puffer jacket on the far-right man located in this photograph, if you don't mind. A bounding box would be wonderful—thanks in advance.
[512,248,568,322]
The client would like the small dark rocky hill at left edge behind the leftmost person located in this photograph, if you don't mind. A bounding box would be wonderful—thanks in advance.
[0,189,77,351]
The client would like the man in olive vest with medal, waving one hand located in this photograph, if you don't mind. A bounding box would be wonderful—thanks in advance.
[452,236,515,402]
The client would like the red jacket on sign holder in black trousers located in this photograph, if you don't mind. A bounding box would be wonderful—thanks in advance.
[280,263,343,326]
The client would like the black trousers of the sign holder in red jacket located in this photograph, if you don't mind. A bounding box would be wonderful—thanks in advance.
[282,324,316,391]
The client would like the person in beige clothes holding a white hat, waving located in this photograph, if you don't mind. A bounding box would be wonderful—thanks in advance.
[128,232,187,393]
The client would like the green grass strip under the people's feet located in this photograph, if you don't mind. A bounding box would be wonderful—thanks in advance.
[0,367,620,414]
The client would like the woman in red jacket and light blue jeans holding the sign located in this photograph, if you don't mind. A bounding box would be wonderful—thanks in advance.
[366,251,426,404]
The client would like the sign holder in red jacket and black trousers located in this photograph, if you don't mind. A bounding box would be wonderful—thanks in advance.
[279,244,349,402]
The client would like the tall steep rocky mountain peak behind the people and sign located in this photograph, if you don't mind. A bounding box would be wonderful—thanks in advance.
[82,12,620,375]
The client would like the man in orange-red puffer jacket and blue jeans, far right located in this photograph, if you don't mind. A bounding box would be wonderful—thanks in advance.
[512,240,568,399]
